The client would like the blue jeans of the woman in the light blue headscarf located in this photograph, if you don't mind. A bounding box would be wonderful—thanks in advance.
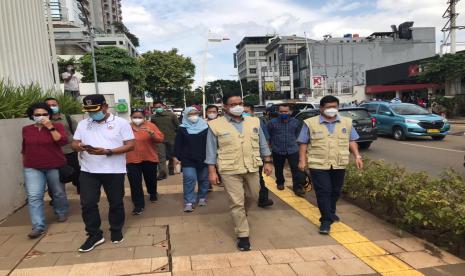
[182,167,209,204]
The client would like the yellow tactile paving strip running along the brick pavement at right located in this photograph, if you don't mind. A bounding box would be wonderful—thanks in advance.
[264,175,423,276]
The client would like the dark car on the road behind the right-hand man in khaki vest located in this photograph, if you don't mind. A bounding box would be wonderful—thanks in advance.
[296,107,378,149]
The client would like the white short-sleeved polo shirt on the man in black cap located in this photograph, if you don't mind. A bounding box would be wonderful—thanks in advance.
[74,114,134,173]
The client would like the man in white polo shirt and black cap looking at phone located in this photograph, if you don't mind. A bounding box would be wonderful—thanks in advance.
[72,94,134,252]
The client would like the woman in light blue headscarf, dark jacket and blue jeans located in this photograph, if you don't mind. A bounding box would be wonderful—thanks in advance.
[174,107,208,212]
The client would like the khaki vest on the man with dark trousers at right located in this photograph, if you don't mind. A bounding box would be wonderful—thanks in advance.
[304,116,352,170]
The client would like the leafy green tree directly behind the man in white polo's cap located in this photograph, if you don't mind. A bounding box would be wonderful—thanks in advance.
[79,46,144,95]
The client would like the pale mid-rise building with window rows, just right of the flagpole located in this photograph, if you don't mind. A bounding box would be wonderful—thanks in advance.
[234,36,273,81]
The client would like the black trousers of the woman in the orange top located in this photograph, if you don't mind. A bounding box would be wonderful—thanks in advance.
[126,161,157,208]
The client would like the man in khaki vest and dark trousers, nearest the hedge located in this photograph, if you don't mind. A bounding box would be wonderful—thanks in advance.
[297,96,363,235]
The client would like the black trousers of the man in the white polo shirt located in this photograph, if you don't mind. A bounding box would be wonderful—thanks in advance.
[79,172,125,236]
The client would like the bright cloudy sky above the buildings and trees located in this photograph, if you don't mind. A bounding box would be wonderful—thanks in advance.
[122,0,465,86]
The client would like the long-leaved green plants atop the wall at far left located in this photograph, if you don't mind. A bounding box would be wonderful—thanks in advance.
[0,81,82,119]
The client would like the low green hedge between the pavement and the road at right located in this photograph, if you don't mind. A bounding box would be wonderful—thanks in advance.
[343,160,465,248]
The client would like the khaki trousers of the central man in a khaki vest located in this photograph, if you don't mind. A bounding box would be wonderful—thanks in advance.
[221,172,260,238]
